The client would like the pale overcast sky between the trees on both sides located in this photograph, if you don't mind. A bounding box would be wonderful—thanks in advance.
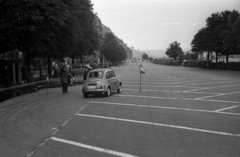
[92,0,240,50]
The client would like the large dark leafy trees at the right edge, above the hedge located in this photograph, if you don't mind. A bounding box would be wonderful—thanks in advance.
[191,10,240,62]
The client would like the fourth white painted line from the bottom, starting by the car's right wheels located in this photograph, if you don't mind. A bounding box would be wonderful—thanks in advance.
[114,95,240,104]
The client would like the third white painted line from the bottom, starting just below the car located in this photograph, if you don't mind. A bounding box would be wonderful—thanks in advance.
[91,101,240,116]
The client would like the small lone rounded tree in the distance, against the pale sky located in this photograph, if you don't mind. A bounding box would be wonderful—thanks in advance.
[165,41,183,60]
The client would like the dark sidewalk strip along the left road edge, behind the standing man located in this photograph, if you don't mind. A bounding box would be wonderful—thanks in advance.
[0,75,83,102]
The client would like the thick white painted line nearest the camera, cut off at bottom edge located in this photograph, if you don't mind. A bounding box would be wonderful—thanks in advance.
[51,137,137,157]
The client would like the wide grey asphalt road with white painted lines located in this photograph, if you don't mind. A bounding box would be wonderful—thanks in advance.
[0,63,240,157]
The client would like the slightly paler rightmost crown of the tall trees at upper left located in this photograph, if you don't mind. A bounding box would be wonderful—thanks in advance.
[59,0,100,57]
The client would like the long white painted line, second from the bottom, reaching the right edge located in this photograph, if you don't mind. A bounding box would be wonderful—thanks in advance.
[78,114,240,137]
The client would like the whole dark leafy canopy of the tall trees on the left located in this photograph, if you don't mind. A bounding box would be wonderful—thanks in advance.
[0,0,99,57]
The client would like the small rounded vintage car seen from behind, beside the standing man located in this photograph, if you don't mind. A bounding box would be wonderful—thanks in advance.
[82,69,122,97]
